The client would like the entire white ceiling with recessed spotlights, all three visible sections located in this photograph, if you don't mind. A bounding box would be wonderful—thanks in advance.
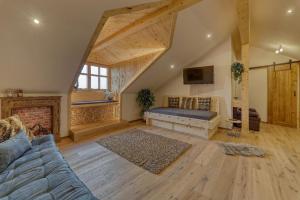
[0,0,300,92]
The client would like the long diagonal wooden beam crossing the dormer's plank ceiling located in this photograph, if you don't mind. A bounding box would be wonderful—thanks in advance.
[93,0,201,52]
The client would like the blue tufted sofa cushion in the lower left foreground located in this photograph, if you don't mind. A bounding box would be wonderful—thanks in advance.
[0,132,96,200]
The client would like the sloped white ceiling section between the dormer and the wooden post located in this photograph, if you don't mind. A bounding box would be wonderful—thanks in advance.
[125,0,236,93]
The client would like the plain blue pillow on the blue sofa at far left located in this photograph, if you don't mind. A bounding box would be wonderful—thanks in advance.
[0,131,31,173]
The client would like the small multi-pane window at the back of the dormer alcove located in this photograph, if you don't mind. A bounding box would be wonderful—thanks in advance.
[75,64,109,90]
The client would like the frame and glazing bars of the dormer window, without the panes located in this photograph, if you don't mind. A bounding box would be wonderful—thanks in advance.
[75,62,111,91]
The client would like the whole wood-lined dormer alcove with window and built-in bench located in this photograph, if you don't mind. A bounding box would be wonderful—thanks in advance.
[70,1,182,140]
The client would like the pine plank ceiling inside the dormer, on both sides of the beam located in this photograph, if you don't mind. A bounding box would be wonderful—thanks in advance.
[88,5,176,66]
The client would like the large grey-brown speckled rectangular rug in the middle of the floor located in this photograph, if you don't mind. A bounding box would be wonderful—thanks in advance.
[97,129,191,174]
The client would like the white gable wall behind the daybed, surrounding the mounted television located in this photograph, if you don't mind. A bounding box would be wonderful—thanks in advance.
[155,39,232,128]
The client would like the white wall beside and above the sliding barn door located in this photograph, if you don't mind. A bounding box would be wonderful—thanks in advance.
[249,47,294,122]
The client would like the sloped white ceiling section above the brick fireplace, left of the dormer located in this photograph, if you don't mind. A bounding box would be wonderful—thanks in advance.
[0,0,158,92]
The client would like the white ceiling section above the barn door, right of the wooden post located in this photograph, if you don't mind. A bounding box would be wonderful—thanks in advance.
[251,0,300,59]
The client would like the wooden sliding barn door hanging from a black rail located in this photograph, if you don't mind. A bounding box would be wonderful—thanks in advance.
[268,63,299,128]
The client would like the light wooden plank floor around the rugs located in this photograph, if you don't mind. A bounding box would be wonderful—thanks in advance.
[59,124,300,200]
